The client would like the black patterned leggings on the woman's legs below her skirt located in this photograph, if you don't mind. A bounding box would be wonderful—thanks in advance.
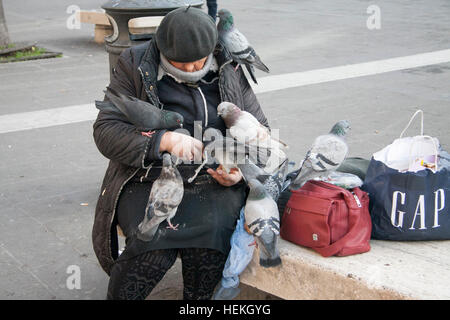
[107,248,227,300]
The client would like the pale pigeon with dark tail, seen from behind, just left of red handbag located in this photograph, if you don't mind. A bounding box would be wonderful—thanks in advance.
[244,179,281,268]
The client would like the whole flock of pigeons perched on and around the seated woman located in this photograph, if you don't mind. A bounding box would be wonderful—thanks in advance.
[96,9,350,267]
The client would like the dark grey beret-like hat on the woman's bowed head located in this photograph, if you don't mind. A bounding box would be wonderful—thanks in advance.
[155,7,218,62]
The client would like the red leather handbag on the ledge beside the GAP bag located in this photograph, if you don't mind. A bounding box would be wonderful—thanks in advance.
[280,180,372,257]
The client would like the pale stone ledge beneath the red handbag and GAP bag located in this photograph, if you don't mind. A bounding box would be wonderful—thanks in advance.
[240,239,450,300]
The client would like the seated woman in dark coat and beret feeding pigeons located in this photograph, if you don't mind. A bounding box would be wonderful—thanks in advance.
[92,7,268,299]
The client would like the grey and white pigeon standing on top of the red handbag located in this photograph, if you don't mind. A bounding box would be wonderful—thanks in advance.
[289,120,350,190]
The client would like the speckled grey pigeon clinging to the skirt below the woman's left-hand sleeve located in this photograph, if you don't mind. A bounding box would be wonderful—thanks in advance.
[137,153,184,241]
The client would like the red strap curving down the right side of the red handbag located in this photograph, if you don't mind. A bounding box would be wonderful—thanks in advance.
[314,189,362,257]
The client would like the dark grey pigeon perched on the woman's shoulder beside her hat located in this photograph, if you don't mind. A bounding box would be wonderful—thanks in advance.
[217,9,269,84]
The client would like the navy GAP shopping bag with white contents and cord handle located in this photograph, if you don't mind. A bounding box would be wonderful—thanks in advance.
[361,110,450,240]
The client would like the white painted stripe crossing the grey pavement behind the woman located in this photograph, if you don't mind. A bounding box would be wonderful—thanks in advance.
[0,49,450,134]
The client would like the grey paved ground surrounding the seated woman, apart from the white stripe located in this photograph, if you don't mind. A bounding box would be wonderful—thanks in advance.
[0,0,450,299]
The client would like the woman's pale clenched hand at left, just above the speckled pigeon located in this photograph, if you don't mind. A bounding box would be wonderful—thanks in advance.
[159,131,203,162]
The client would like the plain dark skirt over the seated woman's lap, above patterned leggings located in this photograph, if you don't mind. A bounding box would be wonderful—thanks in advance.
[117,166,247,260]
